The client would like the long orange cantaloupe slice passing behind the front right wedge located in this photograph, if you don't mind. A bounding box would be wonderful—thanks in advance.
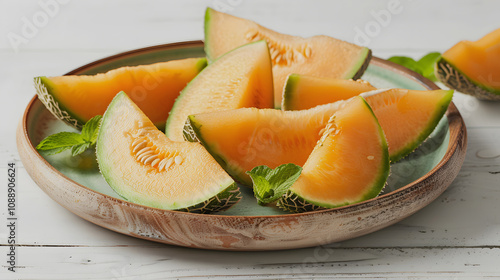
[184,86,453,182]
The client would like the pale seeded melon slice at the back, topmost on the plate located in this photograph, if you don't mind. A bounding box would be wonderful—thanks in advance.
[205,8,371,108]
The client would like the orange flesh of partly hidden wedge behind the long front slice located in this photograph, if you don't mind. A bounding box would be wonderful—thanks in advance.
[281,74,376,110]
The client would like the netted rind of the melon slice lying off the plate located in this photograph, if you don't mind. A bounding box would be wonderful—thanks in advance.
[435,57,500,100]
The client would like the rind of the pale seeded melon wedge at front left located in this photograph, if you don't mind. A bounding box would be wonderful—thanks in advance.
[96,91,242,213]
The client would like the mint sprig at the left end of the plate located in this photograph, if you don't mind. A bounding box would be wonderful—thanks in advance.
[36,115,102,156]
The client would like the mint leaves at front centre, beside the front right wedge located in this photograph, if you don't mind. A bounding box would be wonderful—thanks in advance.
[246,163,302,205]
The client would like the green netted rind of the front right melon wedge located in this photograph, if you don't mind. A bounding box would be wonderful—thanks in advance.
[276,99,390,213]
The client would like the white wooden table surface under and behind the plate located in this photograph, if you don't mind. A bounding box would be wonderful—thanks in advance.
[0,0,500,279]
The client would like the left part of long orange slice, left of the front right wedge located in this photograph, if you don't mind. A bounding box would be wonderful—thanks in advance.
[184,101,345,186]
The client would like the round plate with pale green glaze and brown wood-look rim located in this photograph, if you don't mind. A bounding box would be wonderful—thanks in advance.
[17,41,466,250]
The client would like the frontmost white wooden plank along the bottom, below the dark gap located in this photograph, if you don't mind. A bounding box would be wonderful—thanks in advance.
[0,246,500,280]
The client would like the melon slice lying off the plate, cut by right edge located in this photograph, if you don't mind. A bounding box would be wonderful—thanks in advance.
[436,28,500,100]
